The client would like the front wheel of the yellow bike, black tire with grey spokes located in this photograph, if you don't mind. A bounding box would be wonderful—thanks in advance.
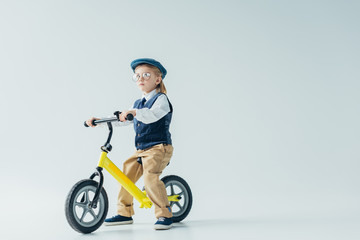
[65,179,109,233]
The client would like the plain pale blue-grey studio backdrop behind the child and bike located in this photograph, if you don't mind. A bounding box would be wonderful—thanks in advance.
[0,0,360,239]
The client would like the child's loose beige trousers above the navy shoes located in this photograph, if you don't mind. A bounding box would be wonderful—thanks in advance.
[118,144,173,218]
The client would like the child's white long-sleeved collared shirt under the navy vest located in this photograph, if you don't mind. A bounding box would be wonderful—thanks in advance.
[113,89,170,127]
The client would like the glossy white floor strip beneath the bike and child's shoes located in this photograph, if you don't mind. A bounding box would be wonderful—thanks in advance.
[0,215,360,240]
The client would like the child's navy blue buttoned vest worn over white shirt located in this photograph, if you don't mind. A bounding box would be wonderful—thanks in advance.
[134,93,173,150]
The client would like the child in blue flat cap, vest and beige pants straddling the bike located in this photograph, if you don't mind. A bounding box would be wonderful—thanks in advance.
[86,58,173,230]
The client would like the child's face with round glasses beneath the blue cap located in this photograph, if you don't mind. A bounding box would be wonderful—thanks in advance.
[135,66,161,93]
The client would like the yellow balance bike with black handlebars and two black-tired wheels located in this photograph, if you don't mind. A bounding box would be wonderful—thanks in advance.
[65,112,192,233]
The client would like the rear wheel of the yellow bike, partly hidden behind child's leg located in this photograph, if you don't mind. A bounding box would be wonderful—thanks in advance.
[161,175,193,222]
